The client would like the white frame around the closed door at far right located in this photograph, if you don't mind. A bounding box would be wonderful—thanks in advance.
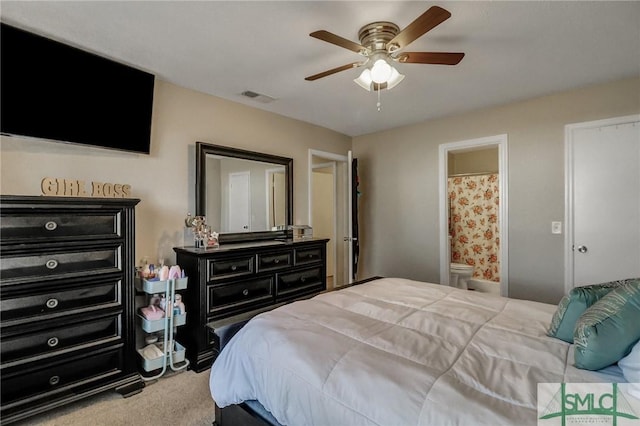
[564,114,640,294]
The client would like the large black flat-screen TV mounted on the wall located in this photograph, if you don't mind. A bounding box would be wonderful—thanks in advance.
[0,23,154,154]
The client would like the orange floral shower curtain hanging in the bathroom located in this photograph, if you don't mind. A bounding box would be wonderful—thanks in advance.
[447,173,500,282]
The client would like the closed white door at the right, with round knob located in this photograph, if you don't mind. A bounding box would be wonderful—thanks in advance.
[566,117,640,289]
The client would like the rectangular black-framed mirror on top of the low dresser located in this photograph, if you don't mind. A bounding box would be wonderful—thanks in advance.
[196,142,293,243]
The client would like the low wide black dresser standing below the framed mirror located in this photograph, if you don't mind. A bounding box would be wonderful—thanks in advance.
[174,239,329,372]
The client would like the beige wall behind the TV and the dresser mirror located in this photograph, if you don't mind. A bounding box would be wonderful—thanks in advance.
[0,80,351,262]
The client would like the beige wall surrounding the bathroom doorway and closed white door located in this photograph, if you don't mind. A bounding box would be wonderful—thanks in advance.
[353,78,640,303]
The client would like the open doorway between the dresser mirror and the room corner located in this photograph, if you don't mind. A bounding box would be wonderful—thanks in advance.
[309,149,353,289]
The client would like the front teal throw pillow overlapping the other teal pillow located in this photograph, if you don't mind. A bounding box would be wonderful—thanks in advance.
[573,279,640,370]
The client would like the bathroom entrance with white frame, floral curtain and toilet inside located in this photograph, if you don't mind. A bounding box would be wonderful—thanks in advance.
[440,135,508,296]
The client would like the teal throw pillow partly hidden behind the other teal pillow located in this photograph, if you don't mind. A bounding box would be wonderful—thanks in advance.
[547,279,631,343]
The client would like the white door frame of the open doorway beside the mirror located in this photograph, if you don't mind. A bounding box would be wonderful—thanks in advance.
[307,149,351,287]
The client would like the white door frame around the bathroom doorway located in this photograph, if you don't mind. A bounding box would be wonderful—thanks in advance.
[438,133,509,297]
